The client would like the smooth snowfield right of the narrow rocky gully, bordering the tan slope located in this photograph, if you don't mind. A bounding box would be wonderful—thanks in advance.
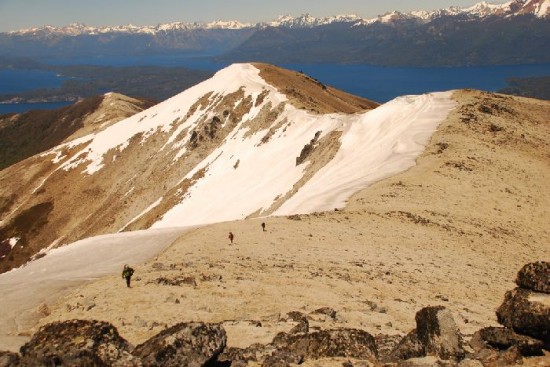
[274,92,455,215]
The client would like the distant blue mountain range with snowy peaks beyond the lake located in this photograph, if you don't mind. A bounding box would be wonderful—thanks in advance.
[0,0,550,67]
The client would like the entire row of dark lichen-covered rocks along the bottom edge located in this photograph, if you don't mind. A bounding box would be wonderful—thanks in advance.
[0,262,550,367]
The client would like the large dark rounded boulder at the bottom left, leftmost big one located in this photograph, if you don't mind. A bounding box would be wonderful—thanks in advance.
[19,320,139,366]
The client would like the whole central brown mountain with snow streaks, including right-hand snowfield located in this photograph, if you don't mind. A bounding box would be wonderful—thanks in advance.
[0,64,454,271]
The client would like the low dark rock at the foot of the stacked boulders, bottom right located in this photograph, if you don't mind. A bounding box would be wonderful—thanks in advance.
[470,327,543,356]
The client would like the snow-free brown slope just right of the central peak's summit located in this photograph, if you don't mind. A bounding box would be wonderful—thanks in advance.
[253,63,379,113]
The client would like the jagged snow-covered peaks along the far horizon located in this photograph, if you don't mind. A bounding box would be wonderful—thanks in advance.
[8,0,550,36]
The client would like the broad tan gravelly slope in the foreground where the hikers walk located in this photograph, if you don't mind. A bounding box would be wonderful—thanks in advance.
[43,91,550,356]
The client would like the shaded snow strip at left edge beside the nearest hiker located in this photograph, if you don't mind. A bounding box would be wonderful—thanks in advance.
[0,228,185,350]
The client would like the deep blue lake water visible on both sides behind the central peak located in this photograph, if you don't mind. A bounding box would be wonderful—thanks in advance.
[0,56,550,113]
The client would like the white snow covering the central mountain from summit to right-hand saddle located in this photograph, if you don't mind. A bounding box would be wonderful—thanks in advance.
[37,64,454,228]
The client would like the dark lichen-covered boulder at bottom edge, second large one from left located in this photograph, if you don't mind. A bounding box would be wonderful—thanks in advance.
[133,322,227,367]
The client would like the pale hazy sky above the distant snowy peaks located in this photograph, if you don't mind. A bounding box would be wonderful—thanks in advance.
[0,0,502,32]
